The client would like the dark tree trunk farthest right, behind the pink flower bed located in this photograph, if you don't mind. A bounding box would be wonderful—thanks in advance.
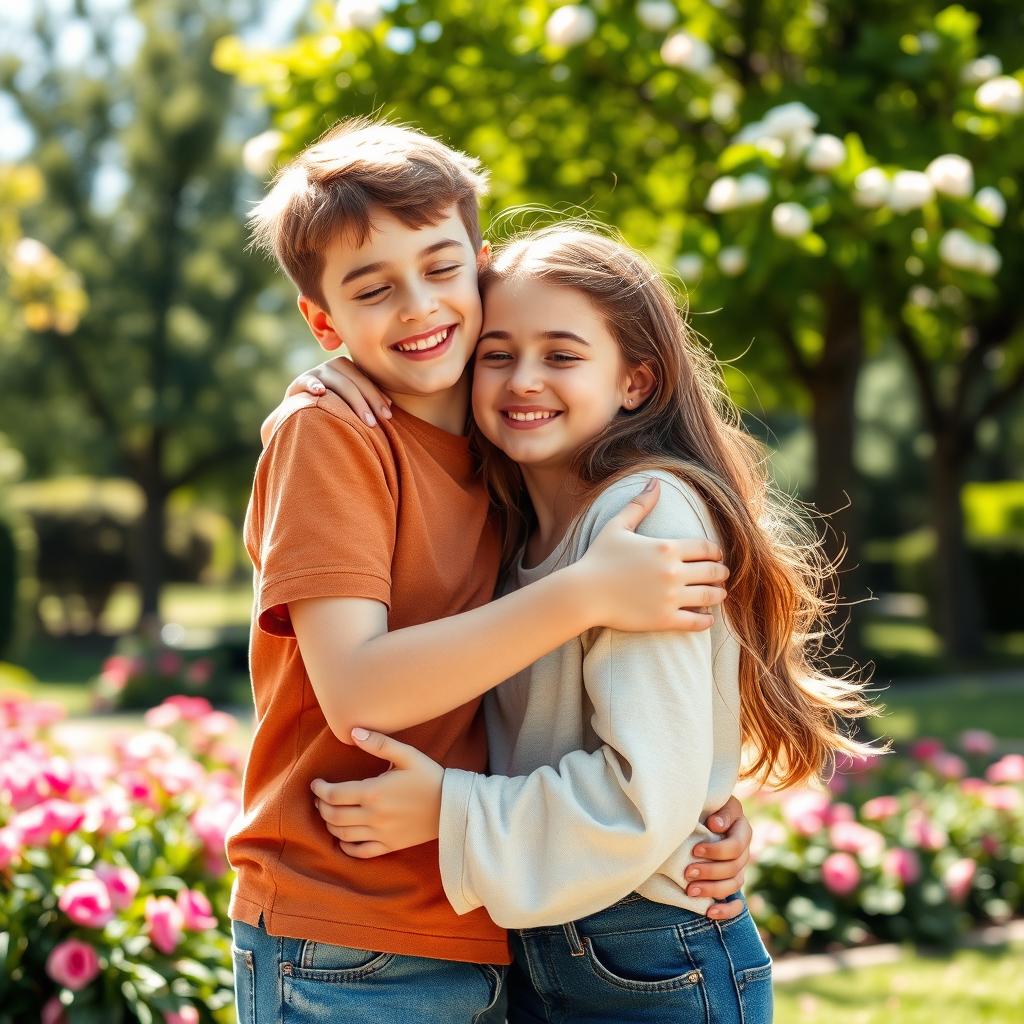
[932,429,984,660]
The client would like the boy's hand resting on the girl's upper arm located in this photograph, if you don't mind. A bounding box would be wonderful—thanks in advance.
[577,478,729,633]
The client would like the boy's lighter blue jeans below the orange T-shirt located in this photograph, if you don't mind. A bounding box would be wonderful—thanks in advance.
[231,921,506,1024]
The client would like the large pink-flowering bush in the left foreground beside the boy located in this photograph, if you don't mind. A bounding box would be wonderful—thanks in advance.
[0,696,240,1024]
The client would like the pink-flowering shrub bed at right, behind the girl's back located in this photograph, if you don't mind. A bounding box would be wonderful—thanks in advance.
[749,730,1024,951]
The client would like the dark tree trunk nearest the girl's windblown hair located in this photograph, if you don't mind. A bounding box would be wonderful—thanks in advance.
[810,293,867,657]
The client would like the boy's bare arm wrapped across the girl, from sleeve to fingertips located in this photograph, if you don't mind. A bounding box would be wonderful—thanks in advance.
[288,481,728,743]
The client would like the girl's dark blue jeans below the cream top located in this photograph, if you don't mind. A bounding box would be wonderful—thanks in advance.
[508,893,772,1024]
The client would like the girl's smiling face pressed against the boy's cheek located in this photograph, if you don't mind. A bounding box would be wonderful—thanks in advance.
[473,280,635,468]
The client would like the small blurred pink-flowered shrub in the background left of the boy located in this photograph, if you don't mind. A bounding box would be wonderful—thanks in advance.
[93,637,230,711]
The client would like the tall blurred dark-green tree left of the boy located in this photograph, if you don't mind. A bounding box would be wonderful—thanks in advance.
[0,0,294,617]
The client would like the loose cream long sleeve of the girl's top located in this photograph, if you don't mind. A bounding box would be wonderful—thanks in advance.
[440,474,714,928]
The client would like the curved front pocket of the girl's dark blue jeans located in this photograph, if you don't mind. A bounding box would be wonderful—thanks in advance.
[583,928,702,992]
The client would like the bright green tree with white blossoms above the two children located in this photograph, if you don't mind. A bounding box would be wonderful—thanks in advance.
[224,0,1024,653]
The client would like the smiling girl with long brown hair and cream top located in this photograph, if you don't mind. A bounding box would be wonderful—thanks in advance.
[313,225,869,1024]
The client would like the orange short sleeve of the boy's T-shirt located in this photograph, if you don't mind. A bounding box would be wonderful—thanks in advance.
[249,406,395,636]
